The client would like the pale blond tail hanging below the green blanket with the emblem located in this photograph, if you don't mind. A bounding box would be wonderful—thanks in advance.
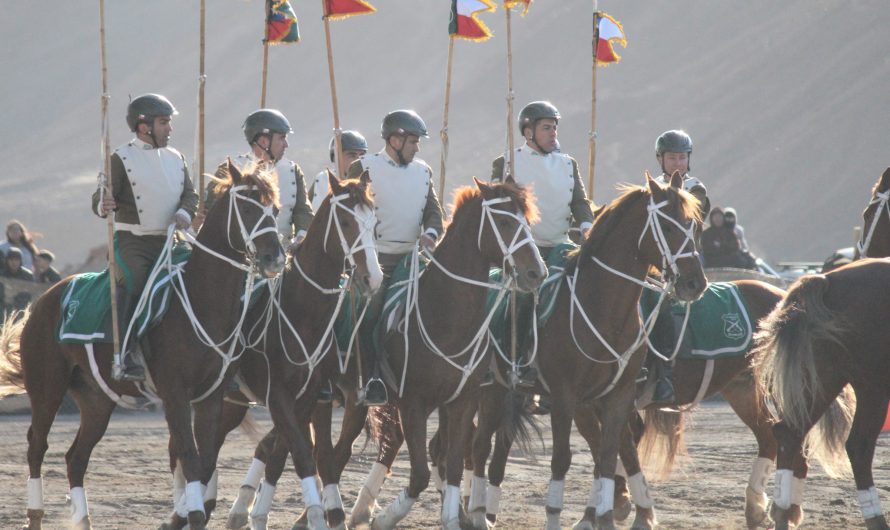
[639,409,687,480]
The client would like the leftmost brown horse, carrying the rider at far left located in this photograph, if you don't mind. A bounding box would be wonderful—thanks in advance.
[0,164,284,530]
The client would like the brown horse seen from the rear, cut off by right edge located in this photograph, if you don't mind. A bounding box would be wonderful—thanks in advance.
[757,259,890,530]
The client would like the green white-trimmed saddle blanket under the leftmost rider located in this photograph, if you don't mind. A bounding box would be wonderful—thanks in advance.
[56,245,192,344]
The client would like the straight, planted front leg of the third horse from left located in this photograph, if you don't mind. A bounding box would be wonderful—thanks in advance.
[440,395,476,530]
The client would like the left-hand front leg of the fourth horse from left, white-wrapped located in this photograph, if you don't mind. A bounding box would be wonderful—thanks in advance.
[545,388,575,530]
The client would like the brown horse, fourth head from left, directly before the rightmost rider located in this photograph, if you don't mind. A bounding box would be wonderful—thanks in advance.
[468,174,707,529]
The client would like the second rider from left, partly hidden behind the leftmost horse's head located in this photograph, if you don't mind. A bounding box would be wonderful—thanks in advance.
[207,109,313,253]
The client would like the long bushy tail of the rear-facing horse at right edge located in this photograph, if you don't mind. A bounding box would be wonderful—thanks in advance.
[754,274,847,432]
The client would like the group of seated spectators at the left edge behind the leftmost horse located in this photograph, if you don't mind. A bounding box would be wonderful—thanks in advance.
[0,220,62,313]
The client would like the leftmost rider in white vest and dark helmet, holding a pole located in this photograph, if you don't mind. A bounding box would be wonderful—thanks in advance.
[93,94,198,381]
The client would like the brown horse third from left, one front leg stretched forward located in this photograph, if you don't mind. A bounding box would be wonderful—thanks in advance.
[358,178,546,529]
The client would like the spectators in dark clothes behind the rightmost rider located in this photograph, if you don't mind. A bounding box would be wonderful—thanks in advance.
[701,206,757,269]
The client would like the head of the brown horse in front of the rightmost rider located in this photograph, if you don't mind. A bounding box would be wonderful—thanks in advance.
[640,172,708,301]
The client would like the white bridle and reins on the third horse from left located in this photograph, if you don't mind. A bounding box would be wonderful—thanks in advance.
[399,193,544,403]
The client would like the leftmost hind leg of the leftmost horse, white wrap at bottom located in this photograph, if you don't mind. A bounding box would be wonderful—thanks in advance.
[22,346,70,530]
